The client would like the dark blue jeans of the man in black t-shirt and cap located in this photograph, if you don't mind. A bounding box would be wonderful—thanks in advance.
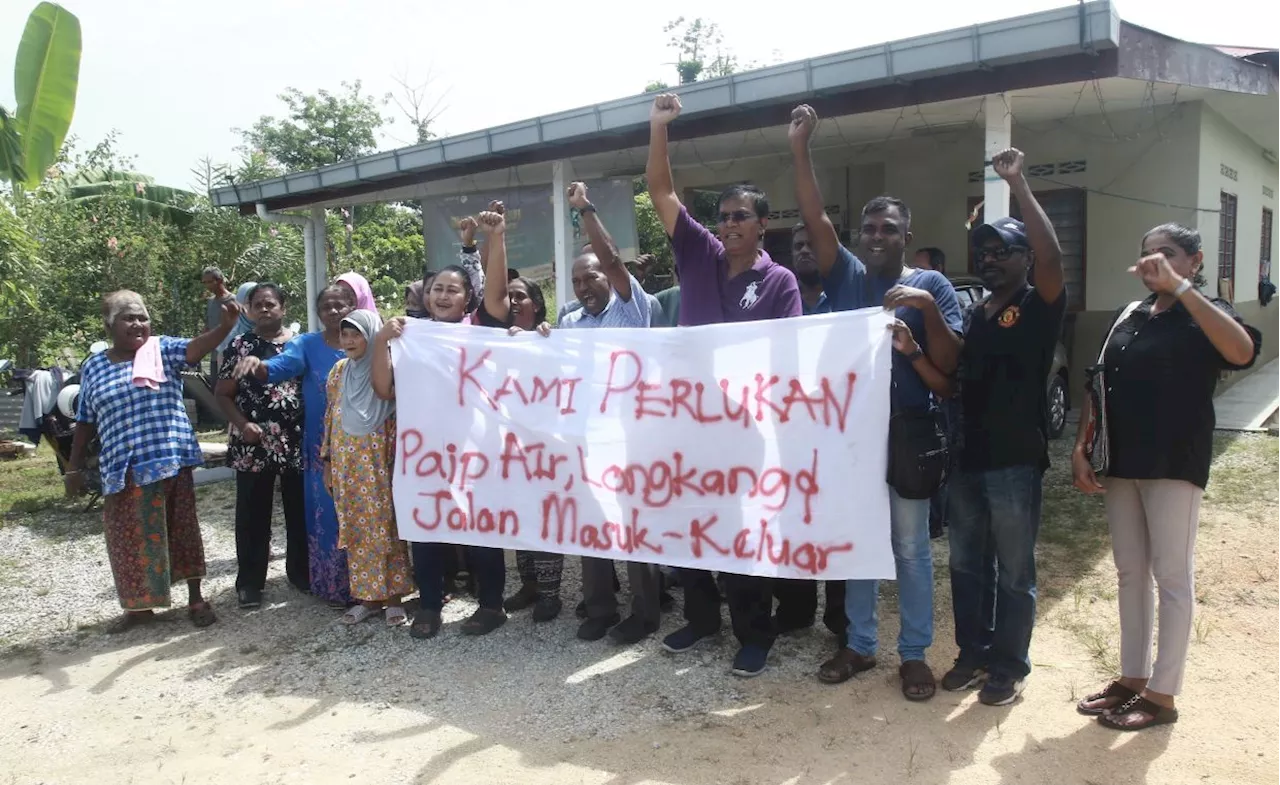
[948,466,1043,679]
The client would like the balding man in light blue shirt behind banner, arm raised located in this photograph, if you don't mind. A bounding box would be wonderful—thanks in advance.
[559,183,662,645]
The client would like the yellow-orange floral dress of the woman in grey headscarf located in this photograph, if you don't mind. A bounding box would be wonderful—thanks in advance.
[320,360,413,601]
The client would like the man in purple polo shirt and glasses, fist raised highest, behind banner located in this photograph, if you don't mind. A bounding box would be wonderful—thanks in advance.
[645,93,801,676]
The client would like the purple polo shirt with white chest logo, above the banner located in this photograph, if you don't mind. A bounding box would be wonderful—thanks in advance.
[671,206,804,327]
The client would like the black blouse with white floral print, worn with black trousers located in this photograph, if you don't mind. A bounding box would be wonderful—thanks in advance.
[219,332,302,474]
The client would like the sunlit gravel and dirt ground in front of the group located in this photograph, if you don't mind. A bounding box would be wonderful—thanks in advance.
[0,437,1280,785]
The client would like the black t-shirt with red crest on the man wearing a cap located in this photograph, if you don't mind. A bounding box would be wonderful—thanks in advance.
[959,286,1066,471]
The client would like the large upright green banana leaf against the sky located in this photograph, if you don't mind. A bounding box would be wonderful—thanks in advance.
[0,3,81,188]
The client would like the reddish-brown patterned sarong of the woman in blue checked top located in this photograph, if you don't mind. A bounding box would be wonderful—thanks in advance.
[102,469,205,611]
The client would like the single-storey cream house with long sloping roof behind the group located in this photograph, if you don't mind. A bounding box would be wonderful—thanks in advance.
[212,0,1280,391]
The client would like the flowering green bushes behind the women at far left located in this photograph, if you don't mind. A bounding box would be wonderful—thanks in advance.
[0,138,305,365]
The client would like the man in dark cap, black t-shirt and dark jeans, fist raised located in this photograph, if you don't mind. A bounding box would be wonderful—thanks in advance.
[942,149,1066,706]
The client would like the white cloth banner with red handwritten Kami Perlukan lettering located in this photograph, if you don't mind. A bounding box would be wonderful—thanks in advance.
[392,309,893,579]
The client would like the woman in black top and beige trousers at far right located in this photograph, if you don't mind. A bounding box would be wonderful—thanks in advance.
[1071,224,1262,730]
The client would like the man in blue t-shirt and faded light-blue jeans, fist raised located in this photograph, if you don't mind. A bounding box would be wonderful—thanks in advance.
[788,105,961,700]
